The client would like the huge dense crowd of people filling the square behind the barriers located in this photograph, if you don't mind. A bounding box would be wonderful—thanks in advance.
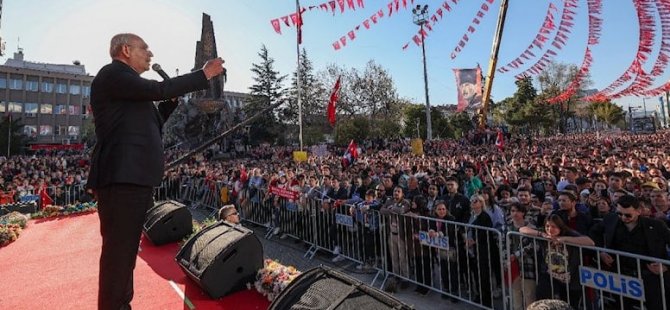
[0,131,670,309]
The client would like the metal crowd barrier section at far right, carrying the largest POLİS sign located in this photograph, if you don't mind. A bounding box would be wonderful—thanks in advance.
[506,232,670,310]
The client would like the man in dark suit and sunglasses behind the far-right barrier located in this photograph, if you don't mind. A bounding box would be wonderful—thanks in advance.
[591,195,670,310]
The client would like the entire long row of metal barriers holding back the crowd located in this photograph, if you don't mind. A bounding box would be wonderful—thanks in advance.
[150,178,670,310]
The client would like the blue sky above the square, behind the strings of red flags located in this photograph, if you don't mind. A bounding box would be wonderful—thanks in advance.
[0,0,670,110]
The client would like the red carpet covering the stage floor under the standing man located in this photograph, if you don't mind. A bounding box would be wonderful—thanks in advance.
[0,213,269,310]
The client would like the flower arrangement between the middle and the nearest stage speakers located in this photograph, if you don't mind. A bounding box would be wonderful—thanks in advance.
[249,258,301,301]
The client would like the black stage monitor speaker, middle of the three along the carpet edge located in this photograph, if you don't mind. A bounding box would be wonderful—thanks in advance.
[175,221,263,299]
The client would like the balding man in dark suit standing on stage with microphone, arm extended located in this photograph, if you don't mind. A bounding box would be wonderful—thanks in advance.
[88,33,223,310]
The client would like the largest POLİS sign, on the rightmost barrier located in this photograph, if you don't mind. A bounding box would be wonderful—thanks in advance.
[579,266,644,301]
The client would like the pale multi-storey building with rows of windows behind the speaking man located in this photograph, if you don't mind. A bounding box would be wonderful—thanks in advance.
[0,50,93,146]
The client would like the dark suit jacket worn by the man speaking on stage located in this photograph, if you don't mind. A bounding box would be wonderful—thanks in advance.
[88,60,209,188]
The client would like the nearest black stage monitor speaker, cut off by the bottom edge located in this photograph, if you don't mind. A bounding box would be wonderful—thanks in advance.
[268,266,413,310]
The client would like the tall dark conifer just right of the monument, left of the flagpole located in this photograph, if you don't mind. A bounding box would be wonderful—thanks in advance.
[243,45,286,144]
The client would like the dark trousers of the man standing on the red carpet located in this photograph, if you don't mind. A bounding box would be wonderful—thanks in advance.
[97,184,153,310]
